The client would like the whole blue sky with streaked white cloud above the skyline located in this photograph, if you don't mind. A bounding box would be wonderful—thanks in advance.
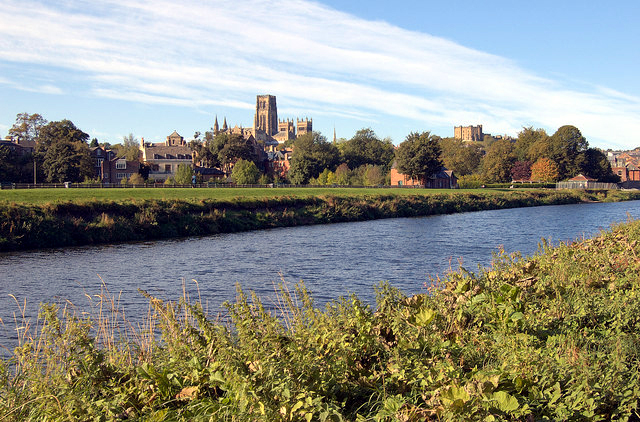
[0,0,640,149]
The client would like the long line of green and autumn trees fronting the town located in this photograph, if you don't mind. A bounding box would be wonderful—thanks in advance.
[0,113,618,185]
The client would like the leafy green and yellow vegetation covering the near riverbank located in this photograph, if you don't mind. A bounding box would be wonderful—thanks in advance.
[0,216,640,421]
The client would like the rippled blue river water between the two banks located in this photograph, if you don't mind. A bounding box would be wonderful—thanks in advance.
[0,201,640,352]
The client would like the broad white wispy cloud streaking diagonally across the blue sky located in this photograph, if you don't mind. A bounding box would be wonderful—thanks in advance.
[0,0,640,148]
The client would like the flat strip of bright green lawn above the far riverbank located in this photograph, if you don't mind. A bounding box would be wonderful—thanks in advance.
[0,188,472,204]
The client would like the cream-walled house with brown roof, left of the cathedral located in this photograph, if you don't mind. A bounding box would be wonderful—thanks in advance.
[140,131,193,181]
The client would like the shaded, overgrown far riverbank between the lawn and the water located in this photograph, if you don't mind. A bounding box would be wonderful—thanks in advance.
[0,189,640,251]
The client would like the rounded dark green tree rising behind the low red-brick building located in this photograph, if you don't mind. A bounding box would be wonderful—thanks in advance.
[396,132,442,179]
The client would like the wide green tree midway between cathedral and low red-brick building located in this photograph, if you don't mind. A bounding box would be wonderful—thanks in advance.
[339,128,394,171]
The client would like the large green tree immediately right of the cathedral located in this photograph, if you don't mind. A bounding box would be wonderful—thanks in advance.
[289,132,340,184]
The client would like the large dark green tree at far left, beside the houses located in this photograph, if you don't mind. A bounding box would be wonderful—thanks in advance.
[36,120,95,182]
